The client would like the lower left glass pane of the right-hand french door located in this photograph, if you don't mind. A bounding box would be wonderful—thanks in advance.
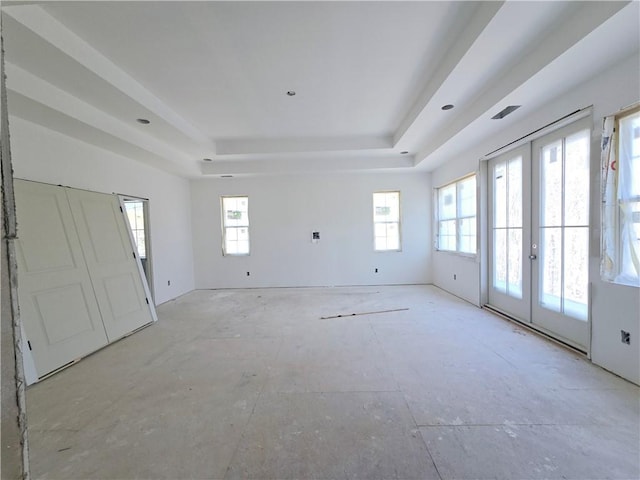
[539,228,562,312]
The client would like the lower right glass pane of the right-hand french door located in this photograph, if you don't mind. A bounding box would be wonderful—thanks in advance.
[564,227,589,320]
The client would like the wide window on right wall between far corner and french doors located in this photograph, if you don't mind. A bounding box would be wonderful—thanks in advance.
[437,175,476,254]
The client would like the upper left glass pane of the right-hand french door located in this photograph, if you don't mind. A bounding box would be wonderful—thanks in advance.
[540,140,563,227]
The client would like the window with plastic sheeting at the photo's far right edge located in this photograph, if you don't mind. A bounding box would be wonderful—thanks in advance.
[602,107,640,286]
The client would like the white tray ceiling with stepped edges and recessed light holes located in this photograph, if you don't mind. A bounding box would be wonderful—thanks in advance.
[2,1,640,178]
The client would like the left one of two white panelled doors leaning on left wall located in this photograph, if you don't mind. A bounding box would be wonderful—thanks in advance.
[15,180,108,377]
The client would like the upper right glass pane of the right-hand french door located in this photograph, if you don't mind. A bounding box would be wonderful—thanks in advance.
[564,130,590,226]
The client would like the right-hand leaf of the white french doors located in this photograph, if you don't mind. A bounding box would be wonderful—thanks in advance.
[531,119,591,349]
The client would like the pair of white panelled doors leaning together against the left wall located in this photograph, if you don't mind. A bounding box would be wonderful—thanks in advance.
[15,179,157,378]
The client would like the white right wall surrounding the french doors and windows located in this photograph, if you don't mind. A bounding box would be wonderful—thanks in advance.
[432,53,640,383]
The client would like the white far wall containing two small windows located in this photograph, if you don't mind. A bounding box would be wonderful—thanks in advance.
[191,173,431,288]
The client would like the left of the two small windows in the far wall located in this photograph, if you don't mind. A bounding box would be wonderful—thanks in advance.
[222,197,249,255]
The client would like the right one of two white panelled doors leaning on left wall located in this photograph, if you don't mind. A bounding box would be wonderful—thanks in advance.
[67,189,153,342]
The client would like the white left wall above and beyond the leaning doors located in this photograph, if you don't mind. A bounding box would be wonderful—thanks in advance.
[9,117,194,304]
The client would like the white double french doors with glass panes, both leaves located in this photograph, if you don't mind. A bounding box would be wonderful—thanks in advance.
[488,119,591,350]
